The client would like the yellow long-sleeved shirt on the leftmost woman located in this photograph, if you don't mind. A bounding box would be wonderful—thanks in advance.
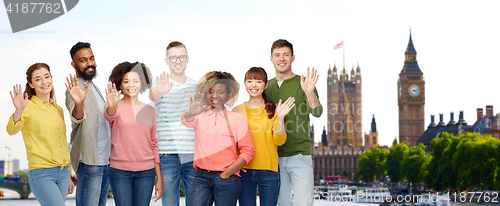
[7,95,69,170]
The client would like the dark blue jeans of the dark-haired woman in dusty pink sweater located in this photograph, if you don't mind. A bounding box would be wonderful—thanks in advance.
[109,167,156,206]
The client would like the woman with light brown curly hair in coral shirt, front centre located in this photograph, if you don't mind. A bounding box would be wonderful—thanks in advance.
[181,72,254,206]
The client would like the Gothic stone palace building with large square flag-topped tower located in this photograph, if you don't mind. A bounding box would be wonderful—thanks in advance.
[311,63,378,180]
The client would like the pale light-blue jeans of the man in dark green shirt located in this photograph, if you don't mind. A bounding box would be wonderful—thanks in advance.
[278,154,314,206]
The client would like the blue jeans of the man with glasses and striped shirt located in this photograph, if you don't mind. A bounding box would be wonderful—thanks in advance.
[160,154,196,206]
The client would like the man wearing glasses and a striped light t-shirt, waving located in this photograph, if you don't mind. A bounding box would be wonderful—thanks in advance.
[149,41,197,206]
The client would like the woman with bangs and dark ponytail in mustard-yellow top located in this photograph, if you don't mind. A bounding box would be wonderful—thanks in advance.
[233,67,295,206]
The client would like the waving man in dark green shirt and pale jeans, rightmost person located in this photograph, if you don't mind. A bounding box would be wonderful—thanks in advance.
[266,39,323,206]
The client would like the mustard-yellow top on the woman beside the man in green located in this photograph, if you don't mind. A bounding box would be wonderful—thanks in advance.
[233,102,286,172]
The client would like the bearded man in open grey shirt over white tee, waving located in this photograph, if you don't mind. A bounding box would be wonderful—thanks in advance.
[66,42,111,206]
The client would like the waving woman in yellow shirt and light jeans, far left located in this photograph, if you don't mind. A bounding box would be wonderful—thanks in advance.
[7,63,80,206]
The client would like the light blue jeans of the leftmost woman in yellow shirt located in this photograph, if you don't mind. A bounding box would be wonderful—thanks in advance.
[28,167,69,206]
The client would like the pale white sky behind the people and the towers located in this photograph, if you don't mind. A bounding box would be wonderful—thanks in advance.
[0,0,500,169]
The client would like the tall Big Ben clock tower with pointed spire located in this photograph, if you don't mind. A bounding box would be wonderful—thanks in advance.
[397,32,425,147]
